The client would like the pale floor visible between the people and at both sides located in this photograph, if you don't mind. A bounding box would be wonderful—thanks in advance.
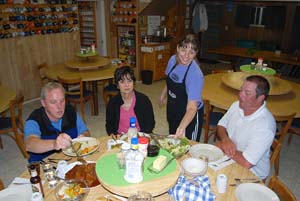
[0,65,300,200]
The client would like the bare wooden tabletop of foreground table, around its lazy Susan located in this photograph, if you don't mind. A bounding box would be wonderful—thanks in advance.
[21,136,257,201]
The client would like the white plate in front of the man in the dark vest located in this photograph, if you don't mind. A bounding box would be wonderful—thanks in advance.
[63,137,100,156]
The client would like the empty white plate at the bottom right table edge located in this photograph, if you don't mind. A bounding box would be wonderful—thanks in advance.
[235,183,279,201]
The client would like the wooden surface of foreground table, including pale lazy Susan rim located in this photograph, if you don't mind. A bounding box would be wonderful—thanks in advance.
[20,136,259,201]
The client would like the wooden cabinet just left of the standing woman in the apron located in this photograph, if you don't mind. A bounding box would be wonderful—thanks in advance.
[140,43,170,80]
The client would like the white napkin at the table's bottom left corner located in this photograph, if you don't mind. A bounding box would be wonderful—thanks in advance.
[0,177,32,201]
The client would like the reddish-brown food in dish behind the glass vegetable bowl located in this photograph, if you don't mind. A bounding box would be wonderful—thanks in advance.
[65,163,100,187]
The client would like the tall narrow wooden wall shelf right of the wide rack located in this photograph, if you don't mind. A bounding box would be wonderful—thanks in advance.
[78,1,97,47]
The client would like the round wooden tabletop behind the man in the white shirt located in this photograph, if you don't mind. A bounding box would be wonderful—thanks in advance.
[202,73,300,117]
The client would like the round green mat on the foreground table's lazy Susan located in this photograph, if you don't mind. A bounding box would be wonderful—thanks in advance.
[96,149,177,186]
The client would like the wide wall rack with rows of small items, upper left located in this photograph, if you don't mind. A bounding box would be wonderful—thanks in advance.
[0,1,78,39]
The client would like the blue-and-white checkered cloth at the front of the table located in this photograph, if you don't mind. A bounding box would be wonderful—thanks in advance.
[168,175,216,201]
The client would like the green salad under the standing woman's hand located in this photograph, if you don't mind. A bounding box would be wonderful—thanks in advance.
[158,137,190,158]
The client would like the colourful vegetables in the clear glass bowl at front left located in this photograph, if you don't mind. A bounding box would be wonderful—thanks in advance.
[56,181,86,201]
